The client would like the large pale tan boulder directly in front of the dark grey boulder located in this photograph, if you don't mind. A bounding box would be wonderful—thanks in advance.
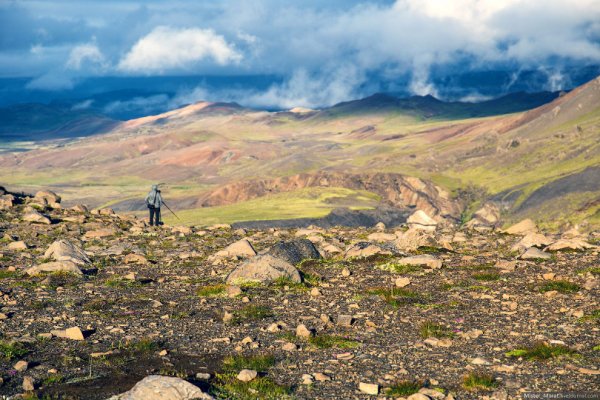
[227,254,302,284]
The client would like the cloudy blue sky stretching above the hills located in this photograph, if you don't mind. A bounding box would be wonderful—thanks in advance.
[0,0,600,108]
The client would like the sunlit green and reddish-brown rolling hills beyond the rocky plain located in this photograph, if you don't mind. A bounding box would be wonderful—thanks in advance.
[0,79,600,229]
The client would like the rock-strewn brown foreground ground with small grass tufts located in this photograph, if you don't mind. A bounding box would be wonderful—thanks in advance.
[0,193,600,399]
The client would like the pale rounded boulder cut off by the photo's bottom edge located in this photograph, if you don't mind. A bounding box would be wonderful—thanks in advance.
[108,375,214,400]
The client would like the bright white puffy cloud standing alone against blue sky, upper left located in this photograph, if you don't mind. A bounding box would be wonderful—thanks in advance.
[118,26,242,73]
